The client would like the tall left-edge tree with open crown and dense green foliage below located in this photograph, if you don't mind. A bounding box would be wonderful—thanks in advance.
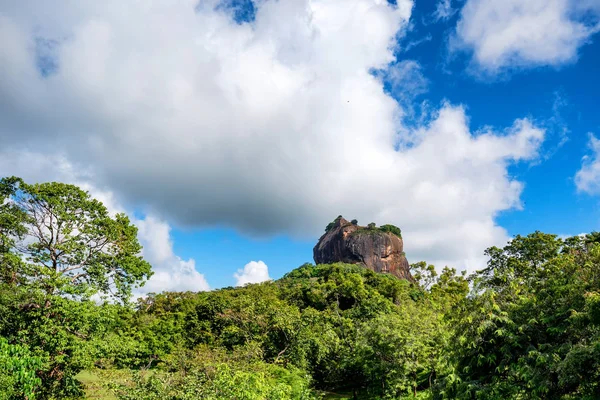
[0,177,151,398]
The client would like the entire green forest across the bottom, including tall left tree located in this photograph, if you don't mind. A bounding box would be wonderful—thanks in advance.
[0,178,600,400]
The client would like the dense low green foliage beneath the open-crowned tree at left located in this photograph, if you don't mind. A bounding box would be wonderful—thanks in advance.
[0,285,135,398]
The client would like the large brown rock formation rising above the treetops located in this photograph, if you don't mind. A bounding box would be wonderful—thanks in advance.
[313,216,413,281]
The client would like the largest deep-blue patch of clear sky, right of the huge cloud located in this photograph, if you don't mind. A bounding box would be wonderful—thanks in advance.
[402,2,600,235]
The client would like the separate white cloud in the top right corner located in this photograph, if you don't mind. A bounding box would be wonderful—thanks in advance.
[451,0,600,74]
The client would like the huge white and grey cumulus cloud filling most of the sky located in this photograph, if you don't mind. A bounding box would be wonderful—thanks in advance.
[0,0,544,272]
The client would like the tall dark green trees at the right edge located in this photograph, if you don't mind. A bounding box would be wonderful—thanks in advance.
[440,232,600,399]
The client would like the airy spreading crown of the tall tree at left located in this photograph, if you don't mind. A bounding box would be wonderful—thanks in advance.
[0,177,152,299]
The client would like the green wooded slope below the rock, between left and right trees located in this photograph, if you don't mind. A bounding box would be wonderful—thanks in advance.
[89,264,468,399]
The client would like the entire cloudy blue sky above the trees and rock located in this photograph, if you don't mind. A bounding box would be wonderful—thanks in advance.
[0,0,600,291]
